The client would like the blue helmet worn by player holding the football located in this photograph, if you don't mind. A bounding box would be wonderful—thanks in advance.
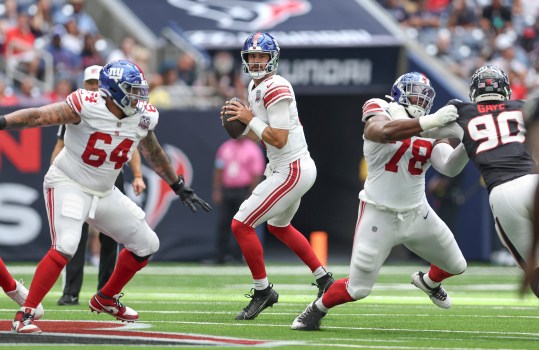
[241,32,281,79]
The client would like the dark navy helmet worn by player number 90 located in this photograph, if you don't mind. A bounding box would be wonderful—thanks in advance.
[470,65,511,102]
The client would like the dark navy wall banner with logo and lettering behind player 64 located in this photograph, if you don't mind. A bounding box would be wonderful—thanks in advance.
[0,111,227,261]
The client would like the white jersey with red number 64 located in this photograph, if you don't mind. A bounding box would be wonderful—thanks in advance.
[45,89,159,194]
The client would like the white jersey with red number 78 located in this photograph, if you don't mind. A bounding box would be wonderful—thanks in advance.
[359,99,435,211]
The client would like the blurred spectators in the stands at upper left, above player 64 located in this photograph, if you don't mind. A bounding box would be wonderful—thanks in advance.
[0,0,244,108]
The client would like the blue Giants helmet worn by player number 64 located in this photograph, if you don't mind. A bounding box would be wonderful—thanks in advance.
[99,60,148,116]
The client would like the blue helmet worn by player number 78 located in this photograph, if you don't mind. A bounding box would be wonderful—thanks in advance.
[391,72,436,118]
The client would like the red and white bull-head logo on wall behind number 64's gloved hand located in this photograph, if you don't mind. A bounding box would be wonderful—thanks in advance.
[125,144,193,229]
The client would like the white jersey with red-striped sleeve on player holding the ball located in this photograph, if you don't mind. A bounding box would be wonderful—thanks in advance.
[249,75,309,167]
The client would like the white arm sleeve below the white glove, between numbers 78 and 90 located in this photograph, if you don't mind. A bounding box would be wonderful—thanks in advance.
[430,142,468,177]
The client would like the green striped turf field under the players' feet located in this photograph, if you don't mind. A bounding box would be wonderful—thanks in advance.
[0,263,539,349]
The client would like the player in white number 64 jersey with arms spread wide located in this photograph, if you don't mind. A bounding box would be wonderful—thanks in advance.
[0,61,211,333]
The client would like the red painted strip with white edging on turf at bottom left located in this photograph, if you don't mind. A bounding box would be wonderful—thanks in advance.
[0,320,276,347]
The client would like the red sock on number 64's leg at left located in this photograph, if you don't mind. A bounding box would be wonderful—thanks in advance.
[24,248,67,309]
